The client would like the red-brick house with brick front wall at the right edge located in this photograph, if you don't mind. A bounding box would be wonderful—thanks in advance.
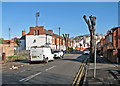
[100,27,120,63]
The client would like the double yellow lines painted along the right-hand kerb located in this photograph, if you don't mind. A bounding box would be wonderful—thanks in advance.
[72,63,85,86]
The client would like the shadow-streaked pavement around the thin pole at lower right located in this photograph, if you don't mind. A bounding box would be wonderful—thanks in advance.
[84,56,120,86]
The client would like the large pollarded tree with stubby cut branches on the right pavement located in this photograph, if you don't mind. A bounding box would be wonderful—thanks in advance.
[83,15,96,62]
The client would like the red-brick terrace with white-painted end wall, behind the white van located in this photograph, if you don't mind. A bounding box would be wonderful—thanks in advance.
[20,26,70,50]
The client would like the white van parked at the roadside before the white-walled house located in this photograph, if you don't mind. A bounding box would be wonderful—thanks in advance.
[30,46,54,63]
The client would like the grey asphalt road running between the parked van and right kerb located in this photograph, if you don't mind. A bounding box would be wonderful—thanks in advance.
[2,54,88,85]
